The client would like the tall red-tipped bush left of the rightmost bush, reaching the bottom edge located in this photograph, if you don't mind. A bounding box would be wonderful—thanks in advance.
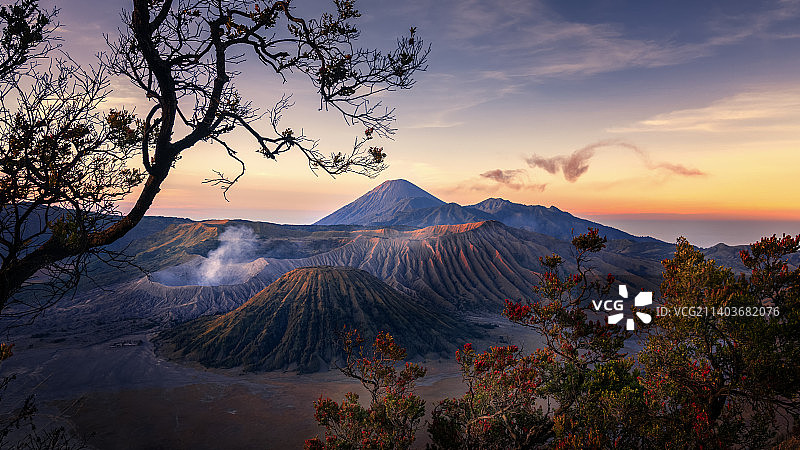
[428,229,641,449]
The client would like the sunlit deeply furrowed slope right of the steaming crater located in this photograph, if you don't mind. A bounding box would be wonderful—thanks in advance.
[259,221,674,313]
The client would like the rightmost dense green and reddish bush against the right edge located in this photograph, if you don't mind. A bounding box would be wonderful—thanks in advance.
[638,236,800,448]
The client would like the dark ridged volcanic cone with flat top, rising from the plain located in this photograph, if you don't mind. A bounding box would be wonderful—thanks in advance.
[157,267,476,372]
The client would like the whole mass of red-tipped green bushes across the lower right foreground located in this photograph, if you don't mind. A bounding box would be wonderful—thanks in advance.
[307,229,800,449]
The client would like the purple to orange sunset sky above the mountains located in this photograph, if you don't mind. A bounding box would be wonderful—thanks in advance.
[42,0,800,245]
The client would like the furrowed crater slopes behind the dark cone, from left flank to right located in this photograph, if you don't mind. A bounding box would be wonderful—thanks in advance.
[53,221,674,325]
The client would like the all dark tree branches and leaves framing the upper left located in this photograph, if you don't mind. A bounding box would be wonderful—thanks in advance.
[0,0,429,315]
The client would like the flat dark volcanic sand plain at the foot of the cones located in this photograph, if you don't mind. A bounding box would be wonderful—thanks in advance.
[0,316,537,449]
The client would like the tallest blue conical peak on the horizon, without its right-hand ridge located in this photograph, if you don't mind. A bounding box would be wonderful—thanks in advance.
[314,180,444,225]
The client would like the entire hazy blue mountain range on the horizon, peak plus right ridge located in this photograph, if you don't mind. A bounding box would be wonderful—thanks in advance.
[316,180,656,242]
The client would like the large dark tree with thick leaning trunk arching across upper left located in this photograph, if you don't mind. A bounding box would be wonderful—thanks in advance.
[0,0,429,309]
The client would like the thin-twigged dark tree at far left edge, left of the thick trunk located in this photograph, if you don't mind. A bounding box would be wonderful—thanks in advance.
[0,0,142,315]
